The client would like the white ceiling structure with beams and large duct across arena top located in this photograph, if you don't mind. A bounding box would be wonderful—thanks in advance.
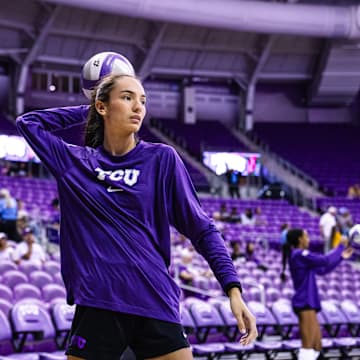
[0,0,360,108]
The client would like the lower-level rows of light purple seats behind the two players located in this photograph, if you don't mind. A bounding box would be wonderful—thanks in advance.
[0,177,360,360]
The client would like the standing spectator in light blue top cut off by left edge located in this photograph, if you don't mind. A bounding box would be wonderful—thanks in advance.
[0,188,21,242]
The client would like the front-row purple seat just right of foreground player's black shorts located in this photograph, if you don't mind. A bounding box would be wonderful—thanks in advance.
[189,302,224,343]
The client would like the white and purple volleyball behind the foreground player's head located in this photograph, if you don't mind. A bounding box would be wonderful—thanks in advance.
[81,51,135,99]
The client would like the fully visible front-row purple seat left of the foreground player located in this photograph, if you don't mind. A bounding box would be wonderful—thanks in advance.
[10,301,55,351]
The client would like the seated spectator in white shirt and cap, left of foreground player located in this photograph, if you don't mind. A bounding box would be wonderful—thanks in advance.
[13,228,46,265]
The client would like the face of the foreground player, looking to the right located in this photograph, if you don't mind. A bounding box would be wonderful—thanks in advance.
[96,76,146,135]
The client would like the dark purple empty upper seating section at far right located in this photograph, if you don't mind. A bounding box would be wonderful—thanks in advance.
[254,123,360,195]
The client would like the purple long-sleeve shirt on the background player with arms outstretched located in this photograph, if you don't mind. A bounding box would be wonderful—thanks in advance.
[289,245,344,311]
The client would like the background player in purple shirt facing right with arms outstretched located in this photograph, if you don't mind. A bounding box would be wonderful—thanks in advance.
[282,229,353,360]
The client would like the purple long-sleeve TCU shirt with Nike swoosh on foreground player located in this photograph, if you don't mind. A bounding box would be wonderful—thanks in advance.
[17,106,240,323]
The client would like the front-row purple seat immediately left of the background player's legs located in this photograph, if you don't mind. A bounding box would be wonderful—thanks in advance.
[271,299,298,339]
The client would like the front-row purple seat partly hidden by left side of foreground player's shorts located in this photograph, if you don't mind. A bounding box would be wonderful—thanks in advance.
[51,303,75,349]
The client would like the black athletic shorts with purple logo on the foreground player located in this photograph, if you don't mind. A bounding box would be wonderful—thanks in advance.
[66,305,190,360]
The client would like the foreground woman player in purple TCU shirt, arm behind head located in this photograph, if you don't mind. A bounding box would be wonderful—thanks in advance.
[17,75,257,360]
